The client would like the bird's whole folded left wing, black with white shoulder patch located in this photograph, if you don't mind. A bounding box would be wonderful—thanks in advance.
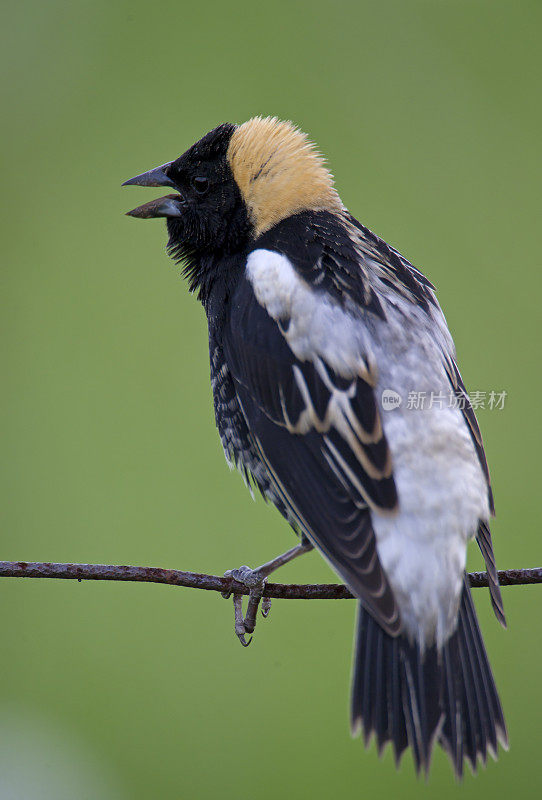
[223,250,400,635]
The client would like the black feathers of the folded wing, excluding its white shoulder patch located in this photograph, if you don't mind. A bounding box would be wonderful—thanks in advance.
[224,281,400,635]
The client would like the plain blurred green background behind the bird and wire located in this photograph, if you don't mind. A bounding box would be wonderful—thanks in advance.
[0,0,542,800]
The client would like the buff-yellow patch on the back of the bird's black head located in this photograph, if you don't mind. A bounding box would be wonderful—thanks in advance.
[228,117,343,236]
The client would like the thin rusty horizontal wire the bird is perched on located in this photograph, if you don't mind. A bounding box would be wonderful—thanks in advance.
[0,561,542,600]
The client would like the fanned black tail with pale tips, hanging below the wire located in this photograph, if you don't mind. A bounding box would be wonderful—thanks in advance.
[352,580,508,777]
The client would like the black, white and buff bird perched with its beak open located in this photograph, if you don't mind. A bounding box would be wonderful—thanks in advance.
[123,116,508,778]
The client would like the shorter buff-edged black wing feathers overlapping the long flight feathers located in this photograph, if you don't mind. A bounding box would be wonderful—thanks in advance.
[225,281,397,511]
